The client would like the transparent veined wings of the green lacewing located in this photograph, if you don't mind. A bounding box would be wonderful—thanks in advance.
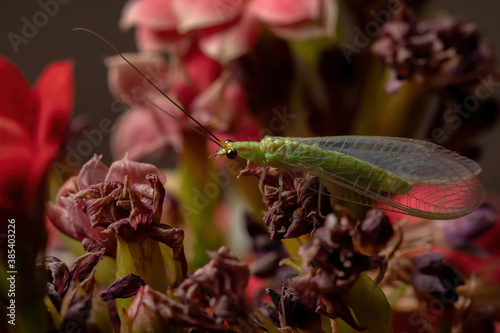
[272,136,484,219]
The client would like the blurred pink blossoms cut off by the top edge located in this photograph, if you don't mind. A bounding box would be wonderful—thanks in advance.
[120,0,338,63]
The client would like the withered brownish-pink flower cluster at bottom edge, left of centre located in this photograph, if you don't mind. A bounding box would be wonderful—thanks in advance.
[122,247,253,332]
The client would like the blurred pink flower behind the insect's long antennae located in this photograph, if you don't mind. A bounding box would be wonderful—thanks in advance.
[107,50,257,160]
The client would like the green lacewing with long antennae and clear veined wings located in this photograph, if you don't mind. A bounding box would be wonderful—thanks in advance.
[75,28,484,219]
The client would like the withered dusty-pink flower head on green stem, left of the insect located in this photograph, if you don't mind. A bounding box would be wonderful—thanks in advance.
[47,156,187,275]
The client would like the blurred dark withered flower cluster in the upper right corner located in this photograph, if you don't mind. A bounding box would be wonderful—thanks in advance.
[371,8,494,92]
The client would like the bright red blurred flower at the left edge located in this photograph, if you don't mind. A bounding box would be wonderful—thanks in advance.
[0,58,73,209]
